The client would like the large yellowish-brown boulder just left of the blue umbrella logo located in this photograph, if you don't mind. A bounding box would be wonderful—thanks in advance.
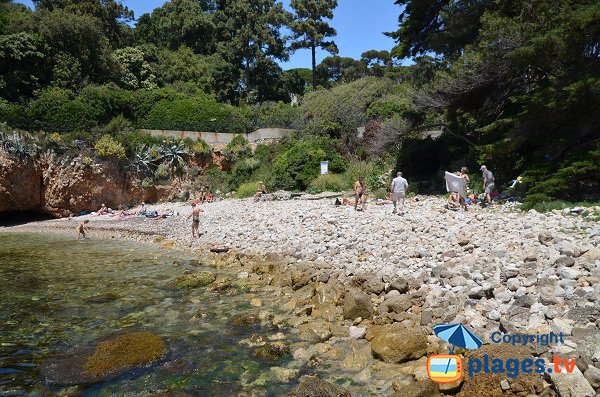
[371,324,427,363]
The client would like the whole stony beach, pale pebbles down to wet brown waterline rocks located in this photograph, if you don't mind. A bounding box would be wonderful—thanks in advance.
[8,197,600,397]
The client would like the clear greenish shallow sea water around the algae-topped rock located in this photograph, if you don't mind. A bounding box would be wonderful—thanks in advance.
[0,234,292,397]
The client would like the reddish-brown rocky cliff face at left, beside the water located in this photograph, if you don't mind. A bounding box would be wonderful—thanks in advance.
[0,152,172,217]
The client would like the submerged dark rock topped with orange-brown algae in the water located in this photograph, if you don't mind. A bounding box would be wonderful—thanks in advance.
[44,332,168,385]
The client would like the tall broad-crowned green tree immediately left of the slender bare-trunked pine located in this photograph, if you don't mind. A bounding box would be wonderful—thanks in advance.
[215,0,290,102]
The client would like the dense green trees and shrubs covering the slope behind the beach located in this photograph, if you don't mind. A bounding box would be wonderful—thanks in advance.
[0,0,600,206]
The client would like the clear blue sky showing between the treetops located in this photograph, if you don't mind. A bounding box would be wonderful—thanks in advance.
[16,0,401,69]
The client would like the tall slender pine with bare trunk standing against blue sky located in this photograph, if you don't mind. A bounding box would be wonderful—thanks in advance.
[290,0,338,89]
